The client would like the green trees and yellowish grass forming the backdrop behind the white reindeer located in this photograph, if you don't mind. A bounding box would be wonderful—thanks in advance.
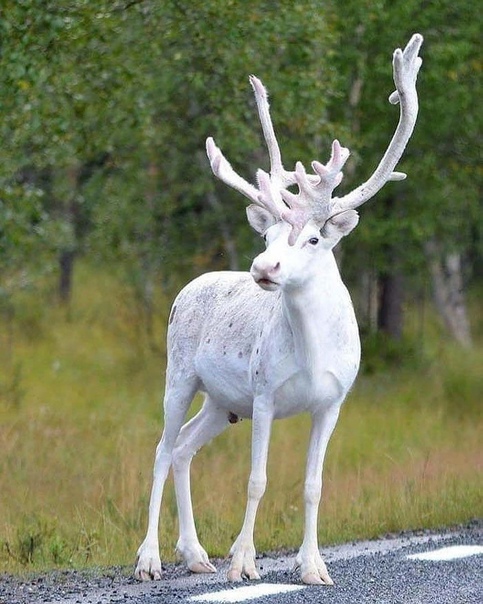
[0,0,483,571]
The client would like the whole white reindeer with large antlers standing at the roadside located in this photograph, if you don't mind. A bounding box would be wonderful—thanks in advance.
[135,34,423,584]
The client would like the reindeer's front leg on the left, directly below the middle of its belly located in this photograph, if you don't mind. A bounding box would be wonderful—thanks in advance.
[228,399,273,581]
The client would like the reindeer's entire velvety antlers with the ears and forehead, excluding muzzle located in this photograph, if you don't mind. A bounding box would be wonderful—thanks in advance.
[206,34,423,266]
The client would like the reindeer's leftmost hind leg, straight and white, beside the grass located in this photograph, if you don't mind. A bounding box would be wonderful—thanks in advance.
[134,380,198,581]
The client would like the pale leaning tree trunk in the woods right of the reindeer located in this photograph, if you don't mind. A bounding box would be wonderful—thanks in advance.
[425,239,471,347]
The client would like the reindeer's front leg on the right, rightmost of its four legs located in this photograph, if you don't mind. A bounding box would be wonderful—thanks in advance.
[295,405,340,585]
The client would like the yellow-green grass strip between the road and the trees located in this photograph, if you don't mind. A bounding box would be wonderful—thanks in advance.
[0,266,483,572]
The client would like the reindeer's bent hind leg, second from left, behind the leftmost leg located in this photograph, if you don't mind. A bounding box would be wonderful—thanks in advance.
[173,396,229,573]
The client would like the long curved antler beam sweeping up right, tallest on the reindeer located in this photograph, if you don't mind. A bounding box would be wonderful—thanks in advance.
[331,34,423,215]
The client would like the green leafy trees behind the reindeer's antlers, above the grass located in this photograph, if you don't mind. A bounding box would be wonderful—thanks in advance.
[0,0,483,312]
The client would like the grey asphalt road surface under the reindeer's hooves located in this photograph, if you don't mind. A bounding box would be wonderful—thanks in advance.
[0,521,483,604]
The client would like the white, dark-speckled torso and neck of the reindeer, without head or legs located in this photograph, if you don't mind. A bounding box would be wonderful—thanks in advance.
[168,248,360,419]
